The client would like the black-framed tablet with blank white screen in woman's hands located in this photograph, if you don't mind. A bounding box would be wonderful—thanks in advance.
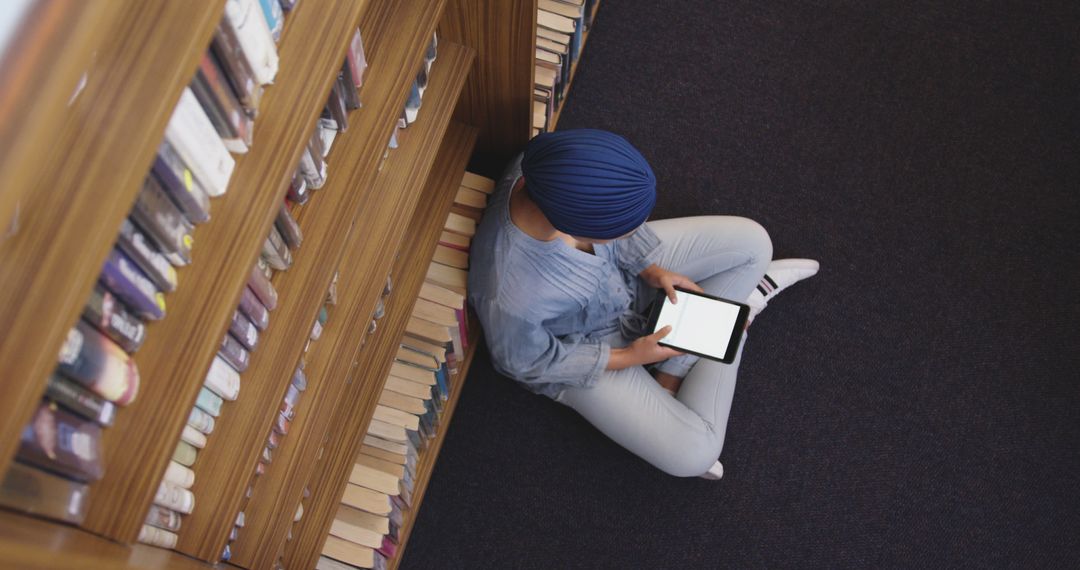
[648,287,750,364]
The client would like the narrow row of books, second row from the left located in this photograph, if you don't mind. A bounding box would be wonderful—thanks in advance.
[131,6,366,559]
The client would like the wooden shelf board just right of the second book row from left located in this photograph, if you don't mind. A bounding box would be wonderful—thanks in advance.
[171,0,443,560]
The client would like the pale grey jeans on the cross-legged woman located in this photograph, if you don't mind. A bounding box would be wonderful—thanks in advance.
[555,216,772,477]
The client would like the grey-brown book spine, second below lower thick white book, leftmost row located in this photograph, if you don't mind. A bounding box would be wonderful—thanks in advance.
[132,175,194,266]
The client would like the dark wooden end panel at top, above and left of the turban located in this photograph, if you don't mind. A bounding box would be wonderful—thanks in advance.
[438,0,537,161]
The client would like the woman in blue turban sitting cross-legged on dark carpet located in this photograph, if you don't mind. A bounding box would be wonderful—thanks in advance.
[469,130,818,478]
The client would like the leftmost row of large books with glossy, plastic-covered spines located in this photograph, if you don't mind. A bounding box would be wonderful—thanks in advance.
[0,0,298,524]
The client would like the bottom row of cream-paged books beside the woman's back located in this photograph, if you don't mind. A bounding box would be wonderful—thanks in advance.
[318,173,495,570]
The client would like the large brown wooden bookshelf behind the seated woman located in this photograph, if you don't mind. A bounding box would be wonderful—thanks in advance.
[0,0,537,569]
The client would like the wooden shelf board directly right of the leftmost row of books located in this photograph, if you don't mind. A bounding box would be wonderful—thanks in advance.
[78,0,360,546]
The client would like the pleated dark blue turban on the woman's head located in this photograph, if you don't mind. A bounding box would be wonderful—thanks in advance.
[522,128,657,240]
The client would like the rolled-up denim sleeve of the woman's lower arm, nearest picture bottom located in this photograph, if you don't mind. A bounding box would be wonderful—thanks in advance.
[476,301,611,389]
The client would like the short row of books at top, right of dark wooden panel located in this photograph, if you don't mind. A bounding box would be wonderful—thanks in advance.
[532,0,595,136]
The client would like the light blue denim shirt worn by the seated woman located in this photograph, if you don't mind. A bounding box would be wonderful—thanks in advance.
[469,155,660,397]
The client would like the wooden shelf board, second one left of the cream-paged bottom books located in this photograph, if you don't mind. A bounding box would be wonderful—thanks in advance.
[230,42,473,568]
